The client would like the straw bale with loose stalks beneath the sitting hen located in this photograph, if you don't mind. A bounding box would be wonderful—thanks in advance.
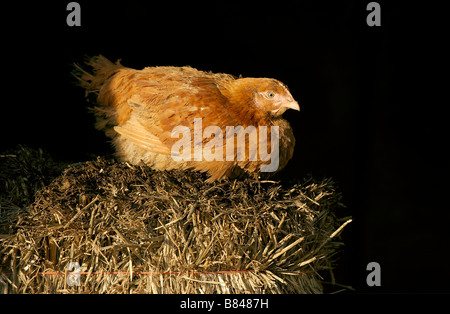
[0,146,350,293]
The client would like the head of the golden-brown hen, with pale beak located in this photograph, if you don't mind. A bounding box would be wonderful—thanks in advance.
[232,78,300,117]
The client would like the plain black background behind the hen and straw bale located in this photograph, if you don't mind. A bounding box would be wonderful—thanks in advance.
[0,0,450,292]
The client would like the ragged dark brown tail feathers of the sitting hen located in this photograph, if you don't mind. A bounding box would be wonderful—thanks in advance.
[72,55,124,94]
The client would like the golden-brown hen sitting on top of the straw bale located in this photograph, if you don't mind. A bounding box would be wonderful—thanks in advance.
[76,56,299,181]
